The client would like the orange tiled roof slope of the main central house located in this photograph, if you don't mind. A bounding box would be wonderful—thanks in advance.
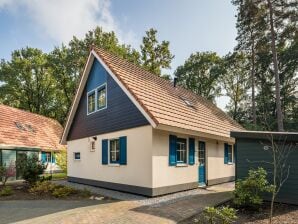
[93,48,244,137]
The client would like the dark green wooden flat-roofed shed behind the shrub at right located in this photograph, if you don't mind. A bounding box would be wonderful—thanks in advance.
[231,131,298,204]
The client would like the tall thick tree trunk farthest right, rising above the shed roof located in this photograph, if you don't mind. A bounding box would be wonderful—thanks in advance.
[267,0,284,131]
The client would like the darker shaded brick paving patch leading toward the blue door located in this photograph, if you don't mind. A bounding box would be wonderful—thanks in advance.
[132,192,231,222]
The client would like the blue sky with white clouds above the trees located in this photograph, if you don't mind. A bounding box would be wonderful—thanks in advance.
[0,0,236,109]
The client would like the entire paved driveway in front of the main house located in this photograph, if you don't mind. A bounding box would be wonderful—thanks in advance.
[0,183,235,224]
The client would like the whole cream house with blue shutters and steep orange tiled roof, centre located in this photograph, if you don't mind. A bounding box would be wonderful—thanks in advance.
[62,48,243,196]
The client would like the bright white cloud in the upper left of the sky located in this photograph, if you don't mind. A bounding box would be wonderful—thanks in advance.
[0,0,135,44]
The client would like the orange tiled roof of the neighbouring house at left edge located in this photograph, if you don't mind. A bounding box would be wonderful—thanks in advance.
[0,105,65,151]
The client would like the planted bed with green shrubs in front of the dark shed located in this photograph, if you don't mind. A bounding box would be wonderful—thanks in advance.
[183,167,298,224]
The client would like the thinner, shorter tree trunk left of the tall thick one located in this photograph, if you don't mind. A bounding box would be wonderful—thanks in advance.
[251,34,257,127]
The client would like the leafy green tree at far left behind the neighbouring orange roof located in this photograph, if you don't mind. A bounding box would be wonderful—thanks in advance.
[0,47,56,117]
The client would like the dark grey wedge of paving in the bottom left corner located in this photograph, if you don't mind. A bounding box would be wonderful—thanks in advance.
[0,200,116,224]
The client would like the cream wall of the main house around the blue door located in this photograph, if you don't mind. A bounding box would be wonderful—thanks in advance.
[152,130,235,188]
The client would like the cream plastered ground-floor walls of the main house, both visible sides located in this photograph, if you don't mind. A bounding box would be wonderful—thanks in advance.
[67,125,235,191]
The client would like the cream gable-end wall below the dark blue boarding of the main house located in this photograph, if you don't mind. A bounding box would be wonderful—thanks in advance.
[67,125,152,187]
